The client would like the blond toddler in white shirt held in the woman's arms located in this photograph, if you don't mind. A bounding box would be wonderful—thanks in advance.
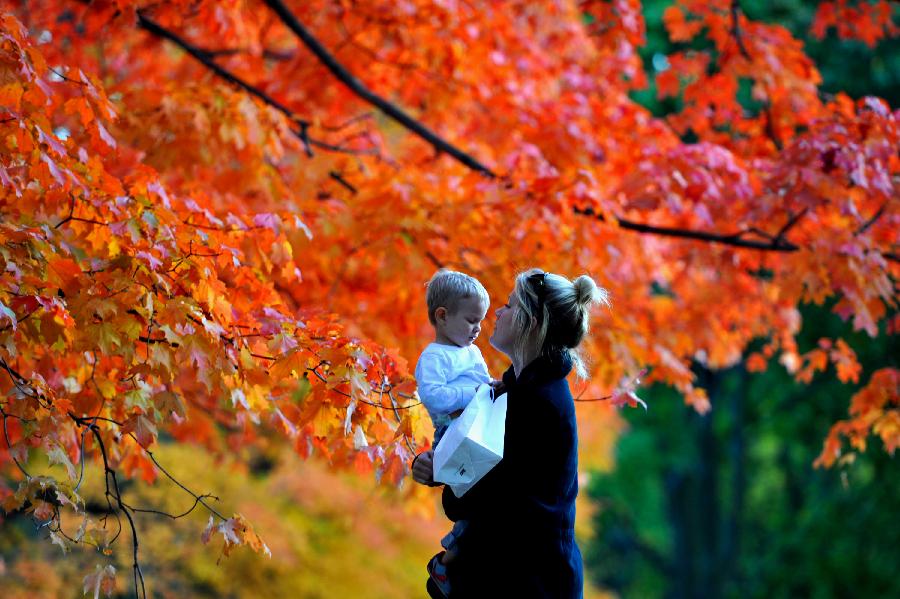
[416,269,494,595]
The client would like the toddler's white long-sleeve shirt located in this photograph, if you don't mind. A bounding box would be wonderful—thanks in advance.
[416,343,491,428]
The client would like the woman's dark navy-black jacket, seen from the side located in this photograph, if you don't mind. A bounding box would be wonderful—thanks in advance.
[442,354,583,599]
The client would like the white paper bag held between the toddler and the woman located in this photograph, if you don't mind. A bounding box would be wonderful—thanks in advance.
[434,385,506,497]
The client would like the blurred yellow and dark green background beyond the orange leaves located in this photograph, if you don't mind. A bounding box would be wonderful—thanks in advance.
[0,0,900,599]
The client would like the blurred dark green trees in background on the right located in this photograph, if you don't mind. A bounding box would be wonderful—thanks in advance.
[585,0,900,598]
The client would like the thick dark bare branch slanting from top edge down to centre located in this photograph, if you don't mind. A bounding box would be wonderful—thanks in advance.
[266,0,497,178]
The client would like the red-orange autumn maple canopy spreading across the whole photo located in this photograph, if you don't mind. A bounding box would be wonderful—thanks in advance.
[0,0,900,588]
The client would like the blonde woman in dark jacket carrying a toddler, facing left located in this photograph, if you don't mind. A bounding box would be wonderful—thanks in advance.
[413,270,608,598]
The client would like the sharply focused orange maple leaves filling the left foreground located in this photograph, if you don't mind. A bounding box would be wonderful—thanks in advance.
[0,7,421,589]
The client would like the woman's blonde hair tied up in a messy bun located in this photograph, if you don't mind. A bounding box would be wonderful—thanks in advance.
[512,269,610,378]
